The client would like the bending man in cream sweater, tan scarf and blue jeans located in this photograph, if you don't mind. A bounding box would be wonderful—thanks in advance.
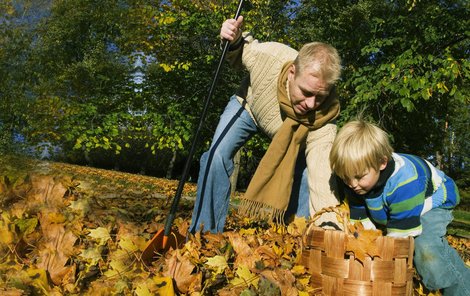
[190,16,341,233]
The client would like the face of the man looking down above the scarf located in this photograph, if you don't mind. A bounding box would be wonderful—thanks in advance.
[288,65,330,115]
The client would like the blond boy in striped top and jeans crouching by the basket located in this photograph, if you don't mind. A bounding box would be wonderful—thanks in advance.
[330,120,470,296]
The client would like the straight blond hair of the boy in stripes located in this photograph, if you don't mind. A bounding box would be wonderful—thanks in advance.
[330,120,393,180]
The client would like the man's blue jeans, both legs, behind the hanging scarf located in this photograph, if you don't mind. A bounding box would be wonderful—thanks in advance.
[189,96,309,233]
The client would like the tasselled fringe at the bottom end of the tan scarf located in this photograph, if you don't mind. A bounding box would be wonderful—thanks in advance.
[238,199,286,227]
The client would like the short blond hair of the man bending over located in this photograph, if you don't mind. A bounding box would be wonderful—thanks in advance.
[294,42,341,85]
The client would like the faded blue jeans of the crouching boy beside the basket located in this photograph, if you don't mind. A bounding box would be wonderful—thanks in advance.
[414,208,470,296]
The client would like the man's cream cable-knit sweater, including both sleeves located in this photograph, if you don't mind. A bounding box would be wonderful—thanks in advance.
[226,33,339,225]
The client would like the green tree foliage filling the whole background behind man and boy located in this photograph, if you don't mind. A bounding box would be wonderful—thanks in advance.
[0,0,470,184]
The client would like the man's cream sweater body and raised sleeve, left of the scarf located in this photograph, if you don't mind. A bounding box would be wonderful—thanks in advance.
[227,33,298,138]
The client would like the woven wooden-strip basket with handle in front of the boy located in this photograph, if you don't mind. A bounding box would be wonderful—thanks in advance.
[301,208,414,296]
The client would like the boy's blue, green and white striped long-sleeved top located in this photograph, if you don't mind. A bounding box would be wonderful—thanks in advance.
[345,153,460,237]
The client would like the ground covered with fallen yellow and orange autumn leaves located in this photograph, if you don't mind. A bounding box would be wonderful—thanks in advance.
[0,157,470,296]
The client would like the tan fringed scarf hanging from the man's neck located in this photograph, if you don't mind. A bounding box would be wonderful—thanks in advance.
[239,62,339,224]
